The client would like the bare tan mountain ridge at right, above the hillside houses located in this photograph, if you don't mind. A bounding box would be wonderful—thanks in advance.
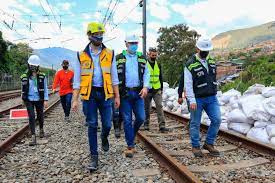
[212,21,275,49]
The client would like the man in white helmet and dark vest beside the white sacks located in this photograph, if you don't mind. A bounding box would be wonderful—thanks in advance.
[184,37,221,157]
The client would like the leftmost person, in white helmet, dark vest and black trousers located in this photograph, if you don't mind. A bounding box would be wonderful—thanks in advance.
[21,55,49,146]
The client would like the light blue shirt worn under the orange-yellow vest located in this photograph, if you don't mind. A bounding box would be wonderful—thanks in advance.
[73,47,119,89]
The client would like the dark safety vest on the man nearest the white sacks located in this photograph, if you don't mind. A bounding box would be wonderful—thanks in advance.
[186,55,217,98]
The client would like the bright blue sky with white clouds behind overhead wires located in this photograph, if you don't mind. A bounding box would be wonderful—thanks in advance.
[0,0,275,52]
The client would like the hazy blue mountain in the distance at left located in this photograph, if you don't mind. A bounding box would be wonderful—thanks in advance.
[34,47,77,69]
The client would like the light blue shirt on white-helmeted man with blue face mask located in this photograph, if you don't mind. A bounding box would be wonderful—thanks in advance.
[125,53,150,89]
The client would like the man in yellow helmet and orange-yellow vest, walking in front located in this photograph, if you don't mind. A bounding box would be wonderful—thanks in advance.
[73,22,120,171]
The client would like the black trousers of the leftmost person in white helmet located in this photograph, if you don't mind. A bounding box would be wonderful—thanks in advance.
[25,101,44,135]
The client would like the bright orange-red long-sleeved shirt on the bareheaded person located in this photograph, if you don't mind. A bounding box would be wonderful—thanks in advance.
[53,69,74,96]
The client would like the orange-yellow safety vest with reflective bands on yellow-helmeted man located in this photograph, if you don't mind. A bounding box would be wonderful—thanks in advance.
[78,45,114,100]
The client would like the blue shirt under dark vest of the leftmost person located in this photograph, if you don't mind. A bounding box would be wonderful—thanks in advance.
[28,77,49,101]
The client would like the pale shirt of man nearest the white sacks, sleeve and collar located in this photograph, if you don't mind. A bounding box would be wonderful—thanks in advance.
[184,55,211,104]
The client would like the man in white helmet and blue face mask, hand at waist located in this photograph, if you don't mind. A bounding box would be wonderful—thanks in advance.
[116,35,150,158]
